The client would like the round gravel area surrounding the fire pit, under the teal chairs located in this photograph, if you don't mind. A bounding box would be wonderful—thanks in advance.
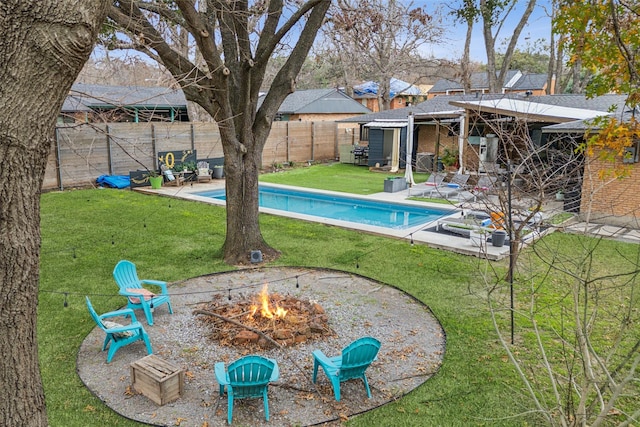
[77,267,445,427]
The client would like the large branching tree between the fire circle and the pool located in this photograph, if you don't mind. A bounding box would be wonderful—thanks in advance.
[109,0,331,264]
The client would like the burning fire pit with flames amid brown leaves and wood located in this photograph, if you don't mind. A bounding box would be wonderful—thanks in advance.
[194,284,335,350]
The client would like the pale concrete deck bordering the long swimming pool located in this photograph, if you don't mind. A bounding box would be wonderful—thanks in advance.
[135,179,535,260]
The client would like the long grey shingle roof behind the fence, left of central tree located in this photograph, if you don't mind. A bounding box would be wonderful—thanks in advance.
[69,83,187,111]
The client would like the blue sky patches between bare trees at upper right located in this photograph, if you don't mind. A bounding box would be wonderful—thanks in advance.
[413,0,551,63]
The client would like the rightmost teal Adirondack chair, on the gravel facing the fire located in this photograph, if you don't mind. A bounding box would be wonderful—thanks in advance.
[313,337,380,401]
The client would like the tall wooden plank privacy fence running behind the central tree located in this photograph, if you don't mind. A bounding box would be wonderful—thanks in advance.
[42,122,353,190]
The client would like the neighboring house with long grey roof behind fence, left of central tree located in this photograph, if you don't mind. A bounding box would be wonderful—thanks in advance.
[58,83,189,123]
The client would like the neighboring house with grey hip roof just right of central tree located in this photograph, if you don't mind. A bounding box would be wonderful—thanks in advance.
[258,89,371,122]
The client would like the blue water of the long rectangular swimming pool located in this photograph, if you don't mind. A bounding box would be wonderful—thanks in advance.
[195,186,453,230]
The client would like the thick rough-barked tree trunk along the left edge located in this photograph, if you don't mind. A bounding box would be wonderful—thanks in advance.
[0,0,108,426]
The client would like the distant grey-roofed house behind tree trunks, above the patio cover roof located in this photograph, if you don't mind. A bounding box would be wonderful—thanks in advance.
[427,70,554,99]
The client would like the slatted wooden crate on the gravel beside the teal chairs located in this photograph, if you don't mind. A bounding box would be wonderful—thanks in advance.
[131,354,184,405]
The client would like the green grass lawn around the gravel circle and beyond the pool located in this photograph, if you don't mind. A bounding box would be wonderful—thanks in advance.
[38,164,635,427]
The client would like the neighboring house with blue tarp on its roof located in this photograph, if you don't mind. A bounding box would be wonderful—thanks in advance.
[353,78,427,112]
